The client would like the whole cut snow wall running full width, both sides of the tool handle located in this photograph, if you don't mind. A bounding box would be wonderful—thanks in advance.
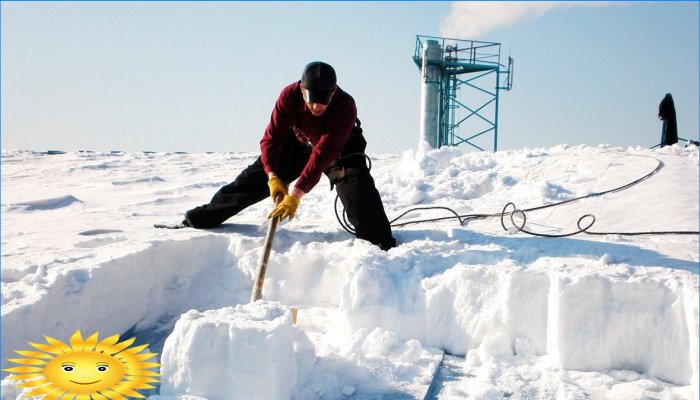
[2,231,698,392]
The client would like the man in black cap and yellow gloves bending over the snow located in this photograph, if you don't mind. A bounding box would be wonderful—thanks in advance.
[183,61,396,250]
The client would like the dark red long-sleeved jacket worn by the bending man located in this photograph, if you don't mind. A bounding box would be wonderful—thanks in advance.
[260,81,357,193]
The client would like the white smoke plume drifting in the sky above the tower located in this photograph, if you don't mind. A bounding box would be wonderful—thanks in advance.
[440,1,609,39]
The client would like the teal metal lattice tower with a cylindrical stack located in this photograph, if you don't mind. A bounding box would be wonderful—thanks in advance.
[413,35,513,151]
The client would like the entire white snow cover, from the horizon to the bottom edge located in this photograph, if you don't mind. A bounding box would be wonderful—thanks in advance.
[1,145,700,400]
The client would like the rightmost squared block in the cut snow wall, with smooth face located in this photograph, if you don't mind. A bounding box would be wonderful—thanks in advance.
[547,275,693,385]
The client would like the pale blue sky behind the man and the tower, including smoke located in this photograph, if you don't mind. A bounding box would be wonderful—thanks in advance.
[1,2,699,153]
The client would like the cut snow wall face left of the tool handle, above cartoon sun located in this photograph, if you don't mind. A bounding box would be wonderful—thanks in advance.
[2,235,249,368]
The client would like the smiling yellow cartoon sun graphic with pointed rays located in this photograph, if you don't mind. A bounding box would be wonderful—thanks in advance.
[3,330,160,400]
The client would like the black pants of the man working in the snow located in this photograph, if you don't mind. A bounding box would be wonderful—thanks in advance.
[186,132,396,250]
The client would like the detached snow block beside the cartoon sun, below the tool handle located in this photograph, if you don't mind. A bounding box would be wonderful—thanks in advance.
[160,301,297,400]
